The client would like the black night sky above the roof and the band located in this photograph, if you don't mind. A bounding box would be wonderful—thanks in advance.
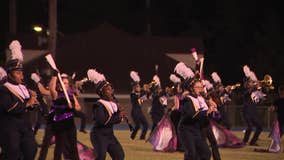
[0,0,284,87]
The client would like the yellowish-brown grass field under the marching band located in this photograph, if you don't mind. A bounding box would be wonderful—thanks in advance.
[36,130,284,160]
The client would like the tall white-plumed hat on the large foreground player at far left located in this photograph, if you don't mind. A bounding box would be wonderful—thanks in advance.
[5,40,23,73]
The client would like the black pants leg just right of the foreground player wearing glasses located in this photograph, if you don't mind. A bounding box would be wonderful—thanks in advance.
[202,125,221,160]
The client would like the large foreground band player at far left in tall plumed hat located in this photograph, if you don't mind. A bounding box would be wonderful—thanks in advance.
[0,41,38,160]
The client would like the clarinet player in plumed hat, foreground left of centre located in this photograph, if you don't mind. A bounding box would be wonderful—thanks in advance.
[88,69,125,160]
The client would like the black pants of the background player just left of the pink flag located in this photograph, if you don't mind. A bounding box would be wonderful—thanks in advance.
[130,111,148,139]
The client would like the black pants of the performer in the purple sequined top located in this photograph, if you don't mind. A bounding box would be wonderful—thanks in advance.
[54,127,79,160]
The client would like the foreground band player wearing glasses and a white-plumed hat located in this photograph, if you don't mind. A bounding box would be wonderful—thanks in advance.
[175,62,212,160]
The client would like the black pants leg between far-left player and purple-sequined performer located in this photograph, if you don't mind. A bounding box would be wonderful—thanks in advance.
[38,123,54,160]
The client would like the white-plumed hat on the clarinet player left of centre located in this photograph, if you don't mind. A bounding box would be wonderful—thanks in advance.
[87,69,111,96]
